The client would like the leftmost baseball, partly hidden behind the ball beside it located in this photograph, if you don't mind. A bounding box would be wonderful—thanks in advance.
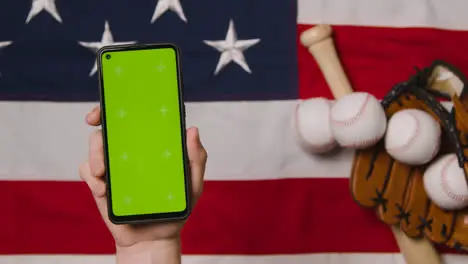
[295,97,337,153]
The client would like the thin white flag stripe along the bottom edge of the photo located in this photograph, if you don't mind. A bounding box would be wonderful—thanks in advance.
[0,253,468,264]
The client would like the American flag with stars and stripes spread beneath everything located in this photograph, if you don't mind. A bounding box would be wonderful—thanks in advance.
[0,0,468,264]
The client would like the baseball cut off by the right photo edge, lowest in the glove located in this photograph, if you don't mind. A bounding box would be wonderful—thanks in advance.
[423,154,468,210]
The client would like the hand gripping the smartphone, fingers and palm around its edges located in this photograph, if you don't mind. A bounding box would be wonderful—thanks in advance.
[80,106,207,262]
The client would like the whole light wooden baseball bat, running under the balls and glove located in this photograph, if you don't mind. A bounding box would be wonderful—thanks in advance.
[300,24,442,264]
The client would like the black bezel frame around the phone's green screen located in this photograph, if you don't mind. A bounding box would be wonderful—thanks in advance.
[97,43,192,224]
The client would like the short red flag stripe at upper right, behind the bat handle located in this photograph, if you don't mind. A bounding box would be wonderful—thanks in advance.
[297,25,468,99]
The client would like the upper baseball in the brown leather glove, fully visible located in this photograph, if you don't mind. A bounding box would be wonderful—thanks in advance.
[385,109,441,165]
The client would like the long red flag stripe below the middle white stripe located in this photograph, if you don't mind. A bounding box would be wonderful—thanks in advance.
[0,179,464,254]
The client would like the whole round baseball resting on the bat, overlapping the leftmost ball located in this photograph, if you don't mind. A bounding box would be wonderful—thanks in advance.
[330,92,387,149]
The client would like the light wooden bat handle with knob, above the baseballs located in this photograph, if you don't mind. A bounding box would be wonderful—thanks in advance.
[301,25,353,99]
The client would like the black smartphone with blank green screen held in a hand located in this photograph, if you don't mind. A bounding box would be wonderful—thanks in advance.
[97,44,190,224]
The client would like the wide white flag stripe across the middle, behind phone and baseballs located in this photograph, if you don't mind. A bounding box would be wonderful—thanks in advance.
[0,100,450,181]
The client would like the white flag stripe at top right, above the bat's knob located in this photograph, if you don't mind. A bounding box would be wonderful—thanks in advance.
[298,0,468,30]
